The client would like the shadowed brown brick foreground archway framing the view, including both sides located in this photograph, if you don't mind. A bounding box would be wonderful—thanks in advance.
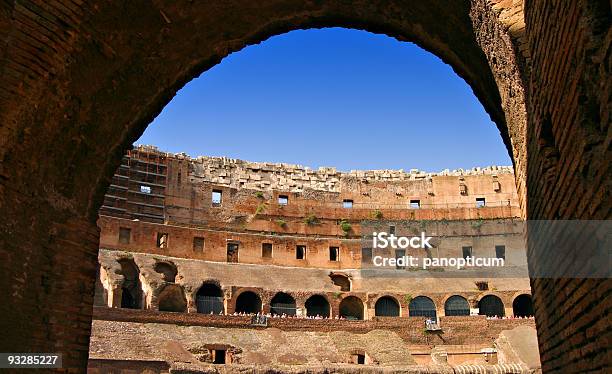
[0,0,612,372]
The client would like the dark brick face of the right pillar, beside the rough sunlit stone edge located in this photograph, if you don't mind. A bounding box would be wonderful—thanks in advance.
[525,0,612,373]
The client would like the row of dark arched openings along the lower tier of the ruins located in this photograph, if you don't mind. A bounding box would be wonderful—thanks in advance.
[103,259,534,320]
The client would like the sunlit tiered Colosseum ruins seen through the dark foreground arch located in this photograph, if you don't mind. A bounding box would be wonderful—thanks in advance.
[89,146,540,373]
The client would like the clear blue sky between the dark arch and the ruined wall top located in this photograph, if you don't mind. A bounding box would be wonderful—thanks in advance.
[136,28,511,171]
